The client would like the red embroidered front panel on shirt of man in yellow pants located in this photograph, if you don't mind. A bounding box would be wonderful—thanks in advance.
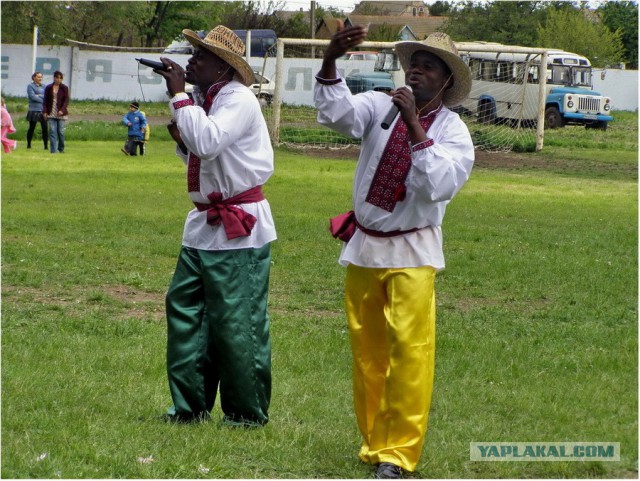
[365,104,442,212]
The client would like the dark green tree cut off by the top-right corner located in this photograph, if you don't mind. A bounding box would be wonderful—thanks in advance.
[597,1,638,69]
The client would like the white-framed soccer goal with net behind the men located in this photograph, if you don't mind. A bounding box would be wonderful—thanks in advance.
[260,38,547,151]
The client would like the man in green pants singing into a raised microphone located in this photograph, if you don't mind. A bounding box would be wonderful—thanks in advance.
[154,26,276,426]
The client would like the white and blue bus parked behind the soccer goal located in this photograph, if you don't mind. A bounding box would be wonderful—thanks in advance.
[459,42,613,130]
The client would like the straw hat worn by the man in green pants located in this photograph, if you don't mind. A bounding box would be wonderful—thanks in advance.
[182,25,255,86]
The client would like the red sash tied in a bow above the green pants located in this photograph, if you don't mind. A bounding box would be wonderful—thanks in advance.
[193,185,264,240]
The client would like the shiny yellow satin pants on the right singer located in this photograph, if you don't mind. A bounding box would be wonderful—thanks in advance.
[345,265,436,471]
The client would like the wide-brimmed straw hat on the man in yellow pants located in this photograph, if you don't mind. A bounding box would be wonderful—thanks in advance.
[395,32,471,107]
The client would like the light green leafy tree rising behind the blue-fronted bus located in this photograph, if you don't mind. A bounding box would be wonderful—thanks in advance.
[538,8,624,67]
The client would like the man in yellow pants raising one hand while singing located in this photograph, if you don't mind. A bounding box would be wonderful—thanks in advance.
[315,25,474,478]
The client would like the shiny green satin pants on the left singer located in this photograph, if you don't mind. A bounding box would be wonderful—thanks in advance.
[166,244,271,425]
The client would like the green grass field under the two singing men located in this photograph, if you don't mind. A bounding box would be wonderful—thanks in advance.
[0,114,638,478]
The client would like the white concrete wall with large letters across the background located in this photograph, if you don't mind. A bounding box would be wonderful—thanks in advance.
[0,44,638,110]
